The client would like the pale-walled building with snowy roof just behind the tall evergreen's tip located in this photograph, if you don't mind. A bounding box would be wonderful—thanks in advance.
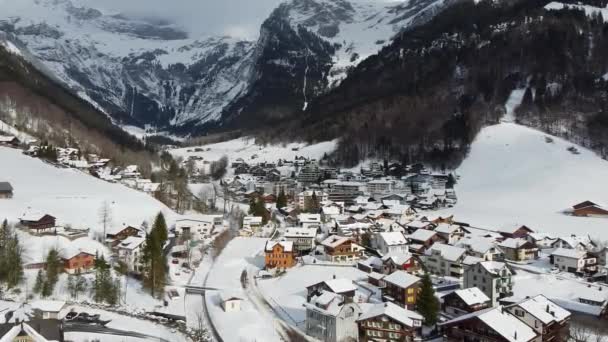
[424,243,467,278]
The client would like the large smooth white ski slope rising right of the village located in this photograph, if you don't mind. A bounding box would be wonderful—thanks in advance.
[435,123,608,240]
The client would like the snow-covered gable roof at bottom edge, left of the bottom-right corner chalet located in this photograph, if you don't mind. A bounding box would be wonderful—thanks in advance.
[440,306,536,342]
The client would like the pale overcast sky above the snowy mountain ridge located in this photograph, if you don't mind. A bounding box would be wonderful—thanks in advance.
[78,0,283,39]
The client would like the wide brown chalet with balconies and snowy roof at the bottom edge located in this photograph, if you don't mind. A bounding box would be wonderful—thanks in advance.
[357,303,423,342]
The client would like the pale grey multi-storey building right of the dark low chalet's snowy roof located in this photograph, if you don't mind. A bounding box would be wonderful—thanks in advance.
[464,261,513,306]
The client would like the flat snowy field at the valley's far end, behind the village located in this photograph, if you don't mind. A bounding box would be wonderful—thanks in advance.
[170,138,337,163]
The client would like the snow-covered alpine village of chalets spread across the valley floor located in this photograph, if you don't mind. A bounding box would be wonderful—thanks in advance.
[0,129,608,342]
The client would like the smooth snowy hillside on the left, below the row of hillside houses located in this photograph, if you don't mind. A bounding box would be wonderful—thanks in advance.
[0,147,176,232]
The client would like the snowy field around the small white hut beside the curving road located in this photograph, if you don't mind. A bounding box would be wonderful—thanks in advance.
[206,238,280,342]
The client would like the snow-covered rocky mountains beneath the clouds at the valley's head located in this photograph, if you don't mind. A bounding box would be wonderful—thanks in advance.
[0,0,446,134]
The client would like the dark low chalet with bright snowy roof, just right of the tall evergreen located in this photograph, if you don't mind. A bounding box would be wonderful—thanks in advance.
[441,287,492,317]
